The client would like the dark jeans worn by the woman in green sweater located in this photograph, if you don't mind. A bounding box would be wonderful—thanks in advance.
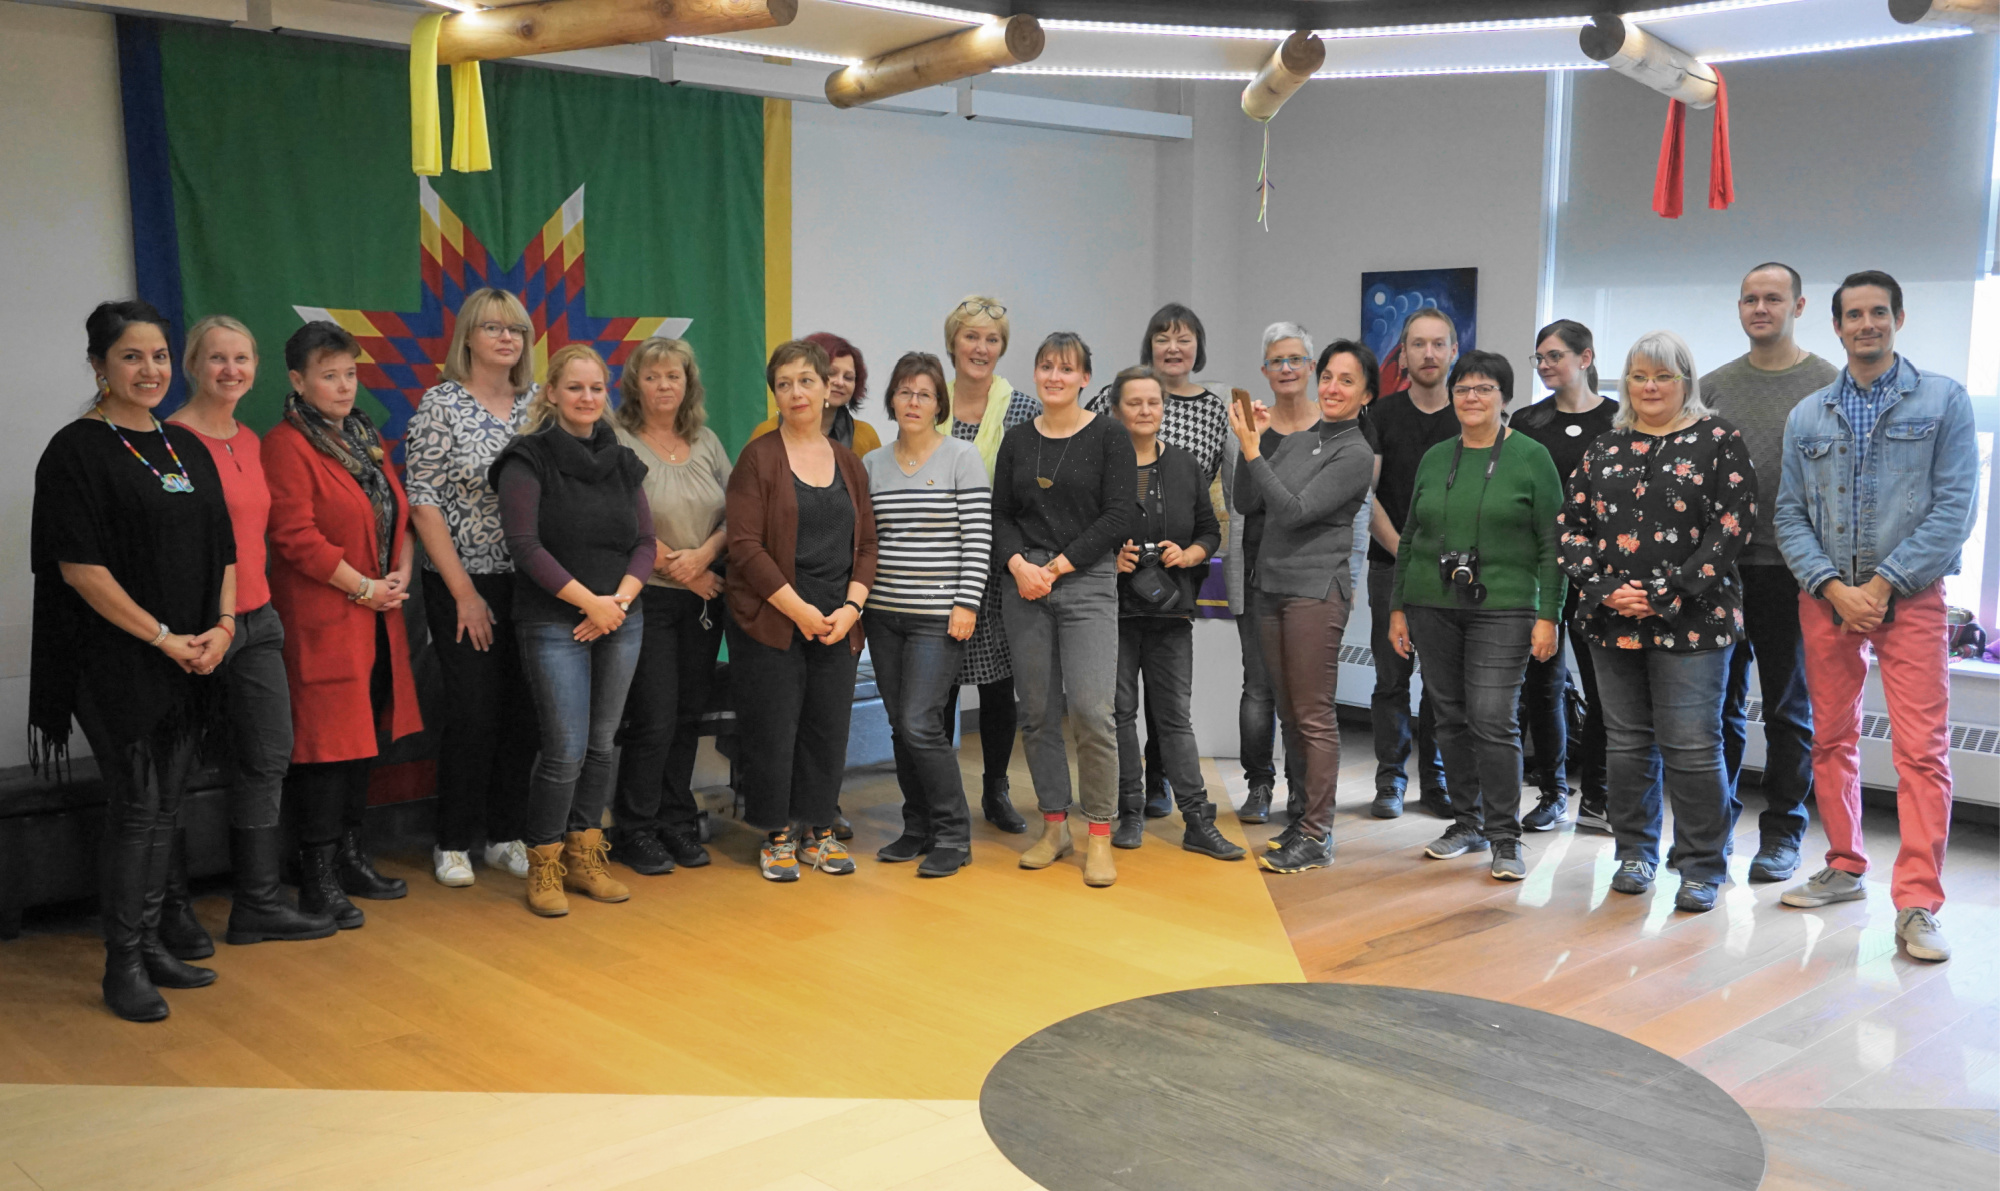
[1406,605,1534,839]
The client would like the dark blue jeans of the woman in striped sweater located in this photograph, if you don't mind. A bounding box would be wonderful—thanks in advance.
[866,609,972,849]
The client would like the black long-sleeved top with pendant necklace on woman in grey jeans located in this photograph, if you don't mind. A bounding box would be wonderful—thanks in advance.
[994,414,1138,572]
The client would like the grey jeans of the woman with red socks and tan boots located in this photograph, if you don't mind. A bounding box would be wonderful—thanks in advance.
[1000,558,1118,823]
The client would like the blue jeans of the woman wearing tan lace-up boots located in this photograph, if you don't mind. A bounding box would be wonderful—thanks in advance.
[516,605,646,847]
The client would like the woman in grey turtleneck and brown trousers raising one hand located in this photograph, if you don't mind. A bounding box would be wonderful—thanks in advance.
[1230,340,1382,873]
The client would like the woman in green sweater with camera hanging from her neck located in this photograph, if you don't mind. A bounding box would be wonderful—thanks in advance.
[1388,352,1564,881]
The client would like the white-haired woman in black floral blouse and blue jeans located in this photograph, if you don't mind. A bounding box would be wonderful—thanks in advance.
[1558,332,1756,911]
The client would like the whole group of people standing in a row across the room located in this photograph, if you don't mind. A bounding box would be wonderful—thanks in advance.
[30,264,1976,1021]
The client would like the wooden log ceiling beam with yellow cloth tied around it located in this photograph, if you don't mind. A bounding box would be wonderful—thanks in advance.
[438,0,798,66]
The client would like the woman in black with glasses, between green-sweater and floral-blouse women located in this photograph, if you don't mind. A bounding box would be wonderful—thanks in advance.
[1508,318,1618,831]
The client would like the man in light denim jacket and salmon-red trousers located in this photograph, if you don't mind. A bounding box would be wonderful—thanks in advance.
[1774,270,1980,961]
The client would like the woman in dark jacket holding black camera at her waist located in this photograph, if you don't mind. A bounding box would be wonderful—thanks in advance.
[1110,364,1244,859]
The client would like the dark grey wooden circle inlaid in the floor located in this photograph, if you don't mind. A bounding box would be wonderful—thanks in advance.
[980,983,1764,1191]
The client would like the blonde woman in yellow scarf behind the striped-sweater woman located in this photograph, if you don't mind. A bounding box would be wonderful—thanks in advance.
[944,294,1042,835]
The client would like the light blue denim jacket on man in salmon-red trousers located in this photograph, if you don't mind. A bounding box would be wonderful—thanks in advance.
[1772,358,1980,596]
